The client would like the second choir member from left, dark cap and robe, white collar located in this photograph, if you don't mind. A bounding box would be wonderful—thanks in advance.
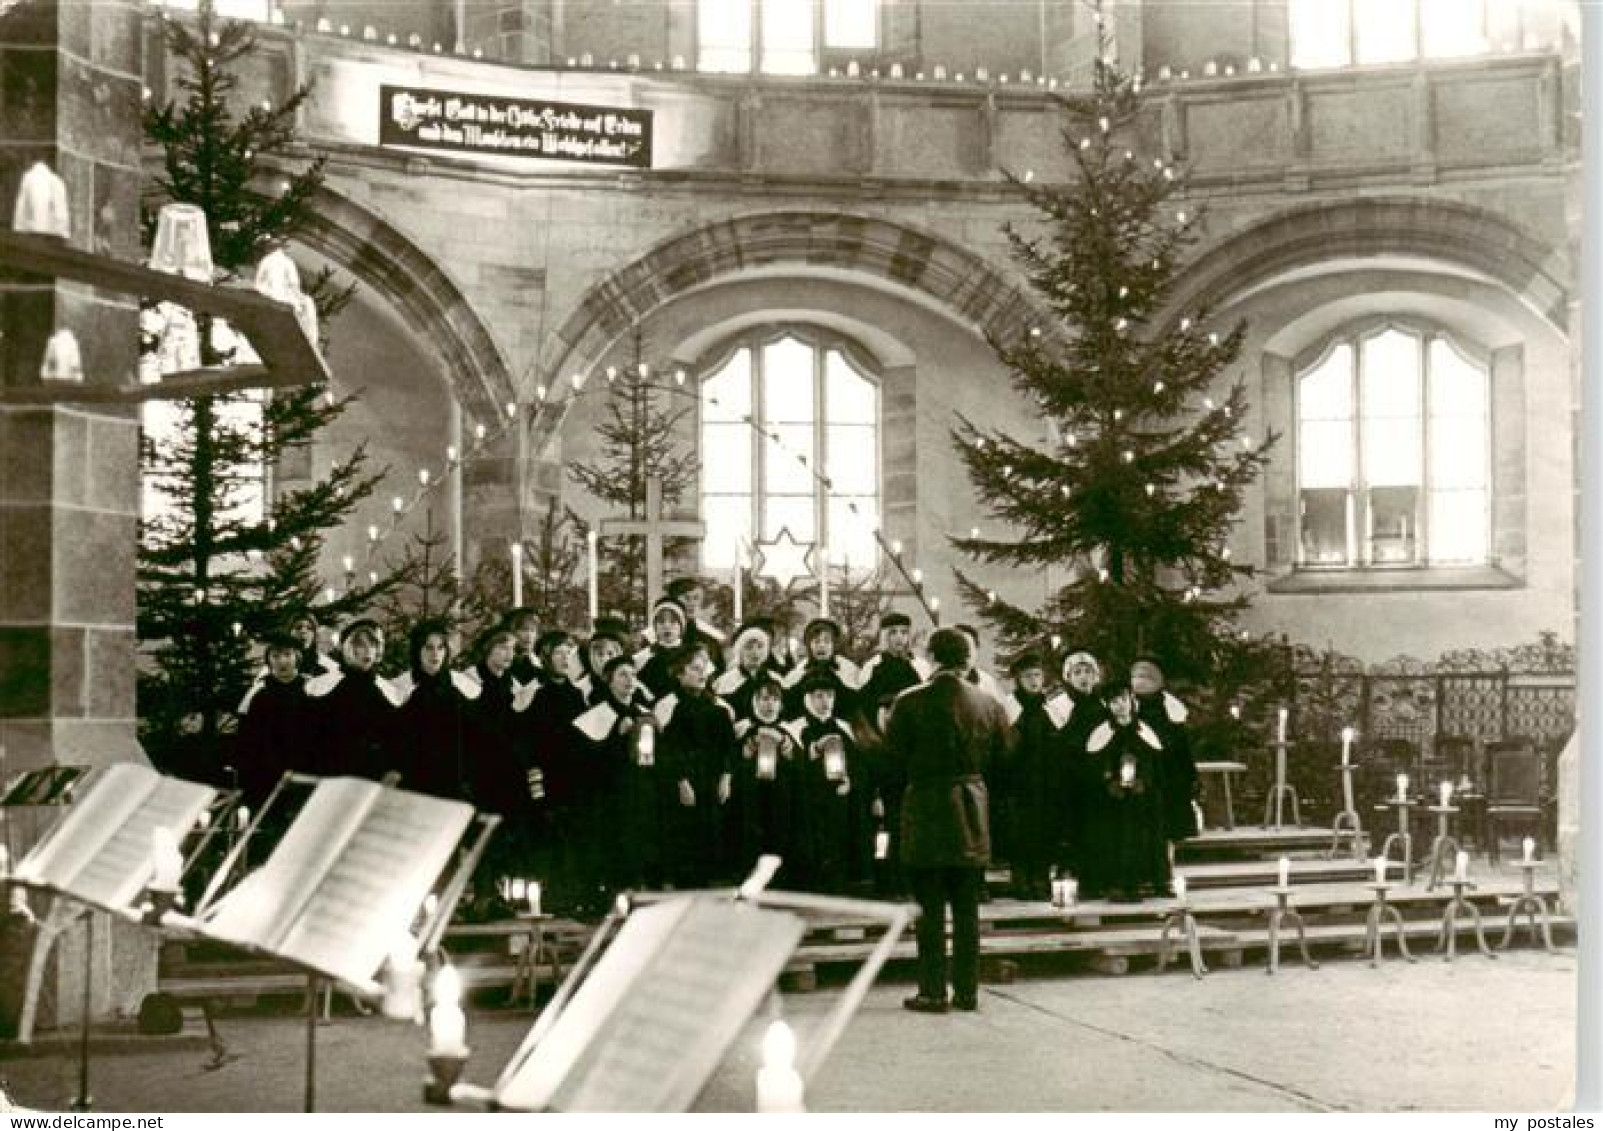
[306,617,401,782]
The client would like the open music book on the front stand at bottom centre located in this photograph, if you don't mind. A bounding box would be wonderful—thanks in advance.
[495,896,805,1112]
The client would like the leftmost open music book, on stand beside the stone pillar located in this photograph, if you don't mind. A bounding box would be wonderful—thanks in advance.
[13,763,216,912]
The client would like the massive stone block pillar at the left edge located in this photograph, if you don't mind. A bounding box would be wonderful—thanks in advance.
[0,0,154,1022]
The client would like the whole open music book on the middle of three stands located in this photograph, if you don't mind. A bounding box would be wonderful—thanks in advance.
[196,777,474,993]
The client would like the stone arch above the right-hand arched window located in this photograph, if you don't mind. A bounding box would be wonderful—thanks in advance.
[1170,197,1576,335]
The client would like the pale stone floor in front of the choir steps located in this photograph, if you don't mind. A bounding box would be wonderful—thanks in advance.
[0,948,1577,1112]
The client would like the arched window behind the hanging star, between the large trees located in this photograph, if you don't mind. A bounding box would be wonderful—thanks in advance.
[701,327,880,569]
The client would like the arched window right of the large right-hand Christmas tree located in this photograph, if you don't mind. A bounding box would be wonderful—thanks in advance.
[1297,324,1491,569]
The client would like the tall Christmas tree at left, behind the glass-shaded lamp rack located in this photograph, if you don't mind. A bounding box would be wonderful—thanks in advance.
[138,3,393,775]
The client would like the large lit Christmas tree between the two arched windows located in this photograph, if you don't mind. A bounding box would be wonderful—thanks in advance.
[954,19,1274,686]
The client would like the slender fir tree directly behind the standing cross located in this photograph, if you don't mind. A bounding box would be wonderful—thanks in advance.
[569,328,697,622]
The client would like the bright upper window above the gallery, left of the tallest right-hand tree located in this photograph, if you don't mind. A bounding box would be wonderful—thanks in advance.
[696,0,878,75]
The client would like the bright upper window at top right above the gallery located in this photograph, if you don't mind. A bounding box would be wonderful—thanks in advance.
[1289,0,1524,69]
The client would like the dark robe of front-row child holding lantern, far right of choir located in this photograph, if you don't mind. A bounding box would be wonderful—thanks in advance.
[1080,718,1169,899]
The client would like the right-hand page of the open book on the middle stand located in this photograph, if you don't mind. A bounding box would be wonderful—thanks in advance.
[277,778,473,985]
